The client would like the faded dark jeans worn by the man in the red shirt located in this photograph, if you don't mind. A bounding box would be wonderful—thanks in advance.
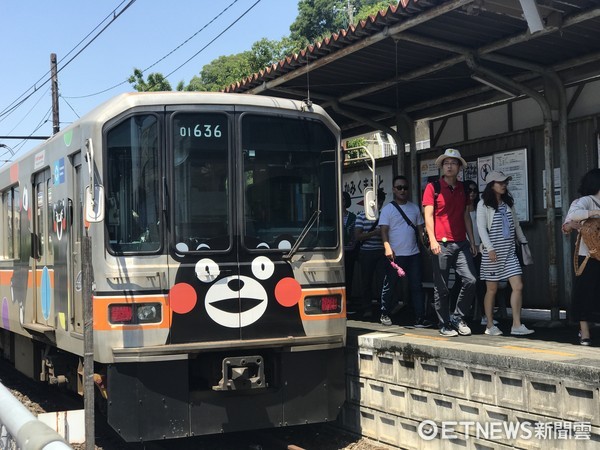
[431,241,477,325]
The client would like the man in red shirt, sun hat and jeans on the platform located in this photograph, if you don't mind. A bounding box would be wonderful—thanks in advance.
[423,148,477,336]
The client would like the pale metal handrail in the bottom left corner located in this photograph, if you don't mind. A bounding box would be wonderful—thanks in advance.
[0,383,72,450]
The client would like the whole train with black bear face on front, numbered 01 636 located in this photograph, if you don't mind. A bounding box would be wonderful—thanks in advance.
[0,92,346,442]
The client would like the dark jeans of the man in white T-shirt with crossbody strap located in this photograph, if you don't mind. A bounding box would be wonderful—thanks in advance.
[381,253,425,320]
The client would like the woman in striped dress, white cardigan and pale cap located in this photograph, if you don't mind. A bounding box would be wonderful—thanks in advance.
[477,171,533,336]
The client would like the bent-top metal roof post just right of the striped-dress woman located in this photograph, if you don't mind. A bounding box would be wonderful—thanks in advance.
[466,56,560,320]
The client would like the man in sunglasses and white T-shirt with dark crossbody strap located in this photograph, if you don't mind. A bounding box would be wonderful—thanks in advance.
[379,175,432,328]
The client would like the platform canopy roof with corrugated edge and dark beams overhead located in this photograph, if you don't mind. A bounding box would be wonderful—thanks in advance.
[226,0,600,137]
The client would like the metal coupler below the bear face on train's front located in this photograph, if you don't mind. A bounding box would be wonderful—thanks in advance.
[212,356,267,391]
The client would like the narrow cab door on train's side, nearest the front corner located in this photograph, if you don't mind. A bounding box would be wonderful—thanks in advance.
[68,153,83,333]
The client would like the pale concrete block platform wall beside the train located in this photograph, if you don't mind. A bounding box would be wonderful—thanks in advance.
[340,332,600,449]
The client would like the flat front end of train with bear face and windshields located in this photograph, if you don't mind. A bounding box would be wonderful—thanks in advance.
[93,100,345,441]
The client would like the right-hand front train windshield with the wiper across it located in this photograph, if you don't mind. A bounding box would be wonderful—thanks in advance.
[241,114,337,251]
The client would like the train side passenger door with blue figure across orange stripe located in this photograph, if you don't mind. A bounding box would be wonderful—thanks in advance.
[31,170,54,328]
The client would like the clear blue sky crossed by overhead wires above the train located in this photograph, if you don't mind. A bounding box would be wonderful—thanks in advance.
[0,0,298,164]
